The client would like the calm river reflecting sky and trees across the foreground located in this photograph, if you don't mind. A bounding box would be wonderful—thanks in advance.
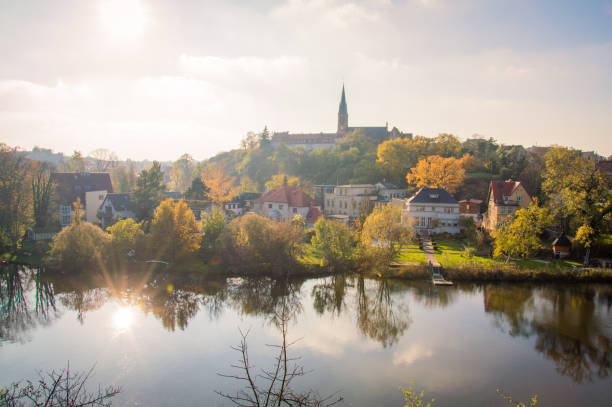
[0,266,612,407]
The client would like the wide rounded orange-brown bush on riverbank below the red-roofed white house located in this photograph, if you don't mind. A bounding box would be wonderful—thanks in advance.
[222,213,304,271]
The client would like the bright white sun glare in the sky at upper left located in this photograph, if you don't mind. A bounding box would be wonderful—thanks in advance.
[97,0,147,42]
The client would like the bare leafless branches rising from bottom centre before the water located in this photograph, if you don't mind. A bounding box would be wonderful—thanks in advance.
[216,300,343,407]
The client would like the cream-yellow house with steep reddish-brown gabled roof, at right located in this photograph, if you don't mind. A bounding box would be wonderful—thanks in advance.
[483,179,532,231]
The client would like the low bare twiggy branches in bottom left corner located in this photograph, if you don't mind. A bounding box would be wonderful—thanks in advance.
[0,364,121,407]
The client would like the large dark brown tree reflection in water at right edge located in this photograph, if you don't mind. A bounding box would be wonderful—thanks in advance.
[485,285,611,383]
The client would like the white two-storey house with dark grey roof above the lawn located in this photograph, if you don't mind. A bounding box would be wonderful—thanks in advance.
[402,188,461,234]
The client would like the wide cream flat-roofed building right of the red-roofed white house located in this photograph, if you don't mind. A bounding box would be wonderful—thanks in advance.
[323,184,378,218]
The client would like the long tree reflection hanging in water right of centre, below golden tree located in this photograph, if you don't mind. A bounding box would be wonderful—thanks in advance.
[357,276,411,348]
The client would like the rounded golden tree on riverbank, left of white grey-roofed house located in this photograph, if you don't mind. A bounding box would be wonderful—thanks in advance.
[361,204,415,260]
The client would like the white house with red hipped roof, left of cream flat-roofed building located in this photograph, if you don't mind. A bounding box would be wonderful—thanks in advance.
[254,186,321,224]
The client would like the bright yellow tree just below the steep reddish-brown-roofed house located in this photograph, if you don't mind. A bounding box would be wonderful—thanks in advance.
[493,200,553,261]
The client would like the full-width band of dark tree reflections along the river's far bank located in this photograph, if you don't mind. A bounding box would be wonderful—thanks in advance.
[0,265,612,383]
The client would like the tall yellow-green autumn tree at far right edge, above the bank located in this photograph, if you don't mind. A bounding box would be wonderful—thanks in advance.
[542,147,612,264]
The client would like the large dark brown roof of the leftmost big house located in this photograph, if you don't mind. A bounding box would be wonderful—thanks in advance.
[52,172,113,205]
